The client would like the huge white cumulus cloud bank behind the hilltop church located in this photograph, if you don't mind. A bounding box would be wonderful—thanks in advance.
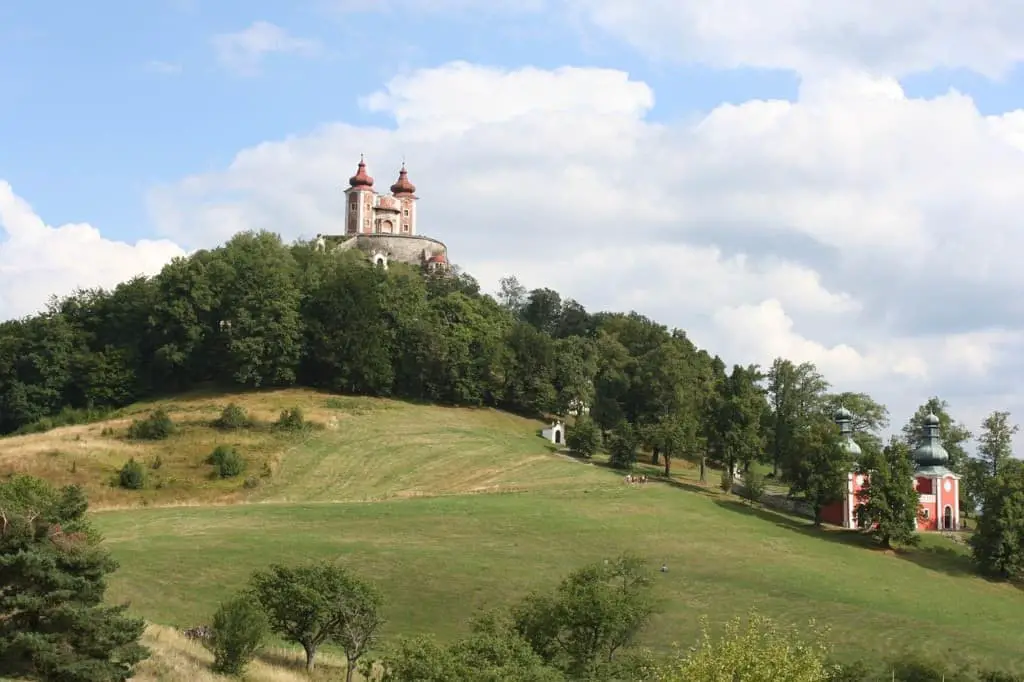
[151,62,1024,436]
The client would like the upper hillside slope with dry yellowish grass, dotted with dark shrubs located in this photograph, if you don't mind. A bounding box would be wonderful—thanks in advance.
[0,389,611,509]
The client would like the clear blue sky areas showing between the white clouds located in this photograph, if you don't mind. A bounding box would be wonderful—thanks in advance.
[6,0,1024,240]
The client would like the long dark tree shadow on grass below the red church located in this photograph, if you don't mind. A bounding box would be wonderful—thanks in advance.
[715,493,978,577]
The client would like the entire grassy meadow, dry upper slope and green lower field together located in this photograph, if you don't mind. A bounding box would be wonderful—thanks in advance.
[0,390,1024,680]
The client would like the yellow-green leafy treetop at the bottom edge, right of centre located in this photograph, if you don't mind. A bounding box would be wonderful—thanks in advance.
[642,612,836,682]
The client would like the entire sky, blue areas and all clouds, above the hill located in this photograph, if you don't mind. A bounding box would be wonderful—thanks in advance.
[0,0,1024,447]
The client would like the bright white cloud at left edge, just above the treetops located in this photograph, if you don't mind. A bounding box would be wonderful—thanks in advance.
[0,180,184,319]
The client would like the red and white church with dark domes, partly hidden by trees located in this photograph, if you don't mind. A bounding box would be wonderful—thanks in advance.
[821,408,959,530]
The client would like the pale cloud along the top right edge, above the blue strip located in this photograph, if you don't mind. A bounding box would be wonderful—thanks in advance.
[569,0,1024,77]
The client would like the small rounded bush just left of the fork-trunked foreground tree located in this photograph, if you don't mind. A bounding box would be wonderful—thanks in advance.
[209,595,270,675]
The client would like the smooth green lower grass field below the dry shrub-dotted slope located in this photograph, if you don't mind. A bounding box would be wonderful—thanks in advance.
[90,483,1024,664]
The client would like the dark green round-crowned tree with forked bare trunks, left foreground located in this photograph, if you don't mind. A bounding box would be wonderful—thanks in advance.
[251,561,383,681]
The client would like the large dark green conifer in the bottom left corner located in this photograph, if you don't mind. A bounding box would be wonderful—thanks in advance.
[0,476,148,682]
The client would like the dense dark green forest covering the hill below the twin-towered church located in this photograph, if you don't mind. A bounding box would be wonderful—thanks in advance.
[0,227,885,477]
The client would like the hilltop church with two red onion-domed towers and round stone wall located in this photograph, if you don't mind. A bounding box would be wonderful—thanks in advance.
[315,157,449,272]
